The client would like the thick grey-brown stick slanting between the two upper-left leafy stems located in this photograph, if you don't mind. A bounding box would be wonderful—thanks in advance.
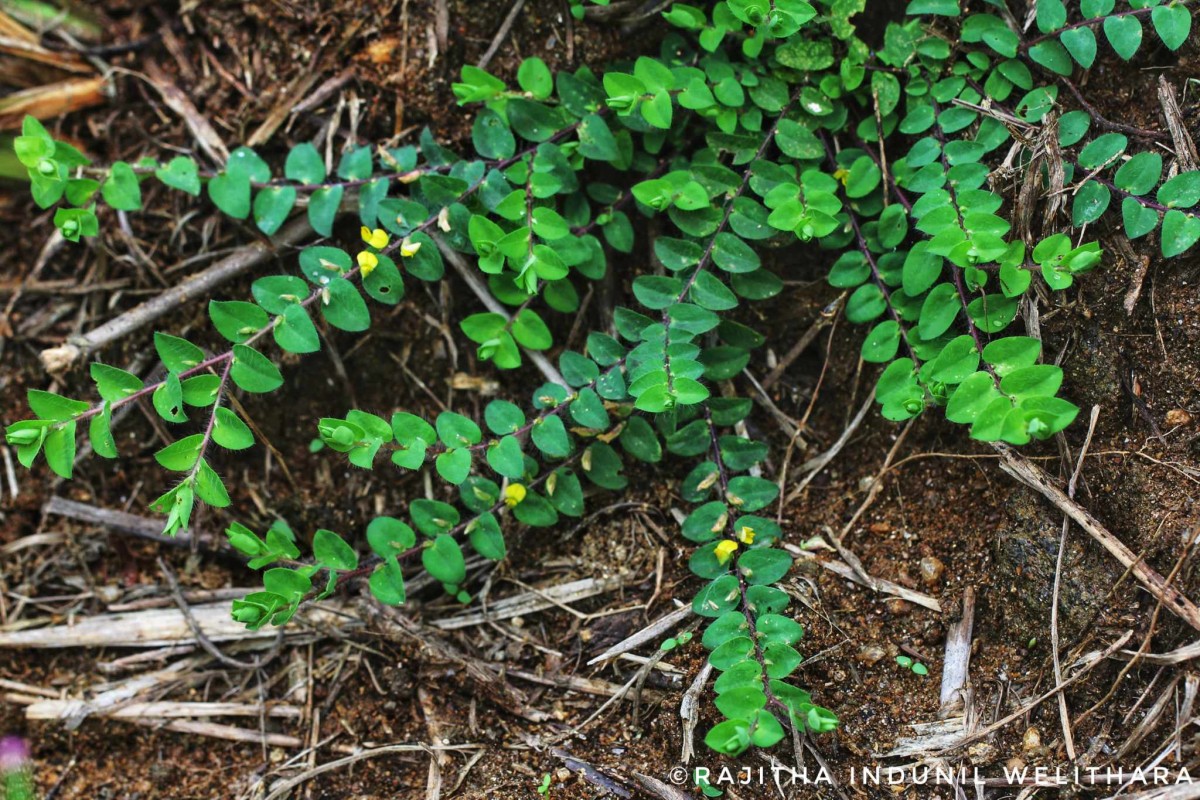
[41,216,312,372]
